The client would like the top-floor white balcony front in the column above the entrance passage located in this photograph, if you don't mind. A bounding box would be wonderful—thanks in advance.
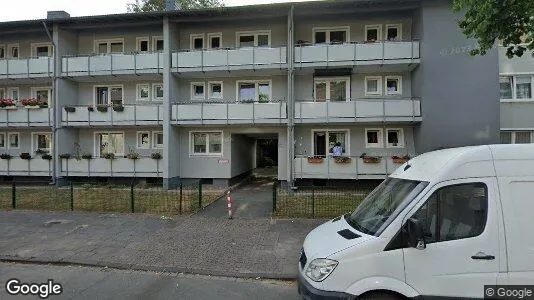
[172,47,287,73]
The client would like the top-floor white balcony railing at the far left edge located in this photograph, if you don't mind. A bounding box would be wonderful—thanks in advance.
[0,57,54,79]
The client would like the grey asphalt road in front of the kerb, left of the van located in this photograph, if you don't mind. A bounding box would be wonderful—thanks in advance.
[0,263,298,300]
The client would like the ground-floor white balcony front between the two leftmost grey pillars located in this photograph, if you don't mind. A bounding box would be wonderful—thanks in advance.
[61,157,163,177]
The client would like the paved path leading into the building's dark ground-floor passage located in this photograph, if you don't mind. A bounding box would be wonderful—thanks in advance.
[199,178,273,220]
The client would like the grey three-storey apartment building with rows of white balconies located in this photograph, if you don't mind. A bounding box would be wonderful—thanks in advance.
[0,0,500,188]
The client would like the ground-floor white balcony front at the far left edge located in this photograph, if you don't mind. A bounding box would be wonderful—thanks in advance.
[0,156,54,176]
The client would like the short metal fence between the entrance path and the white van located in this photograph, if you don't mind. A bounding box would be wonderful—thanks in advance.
[273,183,372,218]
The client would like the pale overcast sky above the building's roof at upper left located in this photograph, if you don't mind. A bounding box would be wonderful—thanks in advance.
[0,0,318,22]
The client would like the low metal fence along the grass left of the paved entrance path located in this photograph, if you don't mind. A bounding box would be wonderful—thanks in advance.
[0,181,224,215]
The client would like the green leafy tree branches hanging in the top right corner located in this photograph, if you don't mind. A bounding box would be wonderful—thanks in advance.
[453,0,534,58]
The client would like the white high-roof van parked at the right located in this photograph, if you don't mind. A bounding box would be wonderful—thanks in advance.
[299,144,534,299]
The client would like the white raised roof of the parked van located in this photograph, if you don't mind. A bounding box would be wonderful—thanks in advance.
[391,144,534,182]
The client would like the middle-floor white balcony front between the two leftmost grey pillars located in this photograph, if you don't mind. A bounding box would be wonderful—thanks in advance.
[61,105,163,127]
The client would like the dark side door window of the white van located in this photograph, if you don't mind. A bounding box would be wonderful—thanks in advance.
[413,183,488,243]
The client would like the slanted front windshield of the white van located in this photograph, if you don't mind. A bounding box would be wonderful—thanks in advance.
[345,177,428,236]
